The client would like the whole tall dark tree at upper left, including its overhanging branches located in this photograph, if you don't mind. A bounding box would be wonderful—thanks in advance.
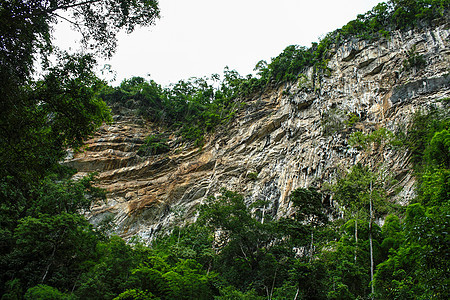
[0,0,159,191]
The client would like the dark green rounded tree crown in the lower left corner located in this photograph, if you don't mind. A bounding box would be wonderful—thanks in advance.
[10,213,98,290]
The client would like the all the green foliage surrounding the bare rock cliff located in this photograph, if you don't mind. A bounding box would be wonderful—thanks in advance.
[0,0,450,300]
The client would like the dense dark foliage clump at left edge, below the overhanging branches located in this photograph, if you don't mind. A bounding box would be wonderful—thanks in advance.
[0,55,110,190]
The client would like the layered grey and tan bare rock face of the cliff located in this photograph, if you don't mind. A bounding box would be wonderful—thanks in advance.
[65,27,450,240]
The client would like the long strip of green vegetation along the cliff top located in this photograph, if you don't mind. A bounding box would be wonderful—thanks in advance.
[102,0,450,145]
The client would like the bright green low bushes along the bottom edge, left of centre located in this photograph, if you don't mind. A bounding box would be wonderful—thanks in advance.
[76,237,216,299]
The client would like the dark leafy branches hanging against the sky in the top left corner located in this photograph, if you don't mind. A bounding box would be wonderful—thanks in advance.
[0,0,159,79]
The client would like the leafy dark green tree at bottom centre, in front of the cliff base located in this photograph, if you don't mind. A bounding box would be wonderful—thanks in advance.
[198,190,294,298]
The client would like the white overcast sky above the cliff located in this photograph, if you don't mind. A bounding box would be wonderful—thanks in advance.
[54,0,383,86]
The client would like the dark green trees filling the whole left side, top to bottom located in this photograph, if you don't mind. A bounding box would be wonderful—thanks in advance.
[0,0,159,299]
